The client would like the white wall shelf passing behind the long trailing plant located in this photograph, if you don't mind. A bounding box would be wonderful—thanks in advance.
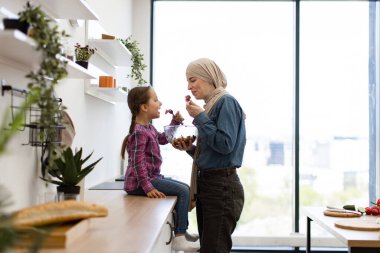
[0,30,96,79]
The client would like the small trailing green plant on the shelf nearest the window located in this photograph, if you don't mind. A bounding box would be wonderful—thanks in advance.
[119,35,147,85]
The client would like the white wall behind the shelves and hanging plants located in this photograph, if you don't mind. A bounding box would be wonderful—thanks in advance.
[0,0,145,210]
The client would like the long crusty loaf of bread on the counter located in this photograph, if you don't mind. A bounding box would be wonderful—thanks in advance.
[12,200,108,227]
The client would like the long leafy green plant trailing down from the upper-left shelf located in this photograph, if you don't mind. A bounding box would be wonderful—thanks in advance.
[19,2,68,175]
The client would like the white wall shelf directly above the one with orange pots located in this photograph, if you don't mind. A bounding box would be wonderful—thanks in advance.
[88,39,132,67]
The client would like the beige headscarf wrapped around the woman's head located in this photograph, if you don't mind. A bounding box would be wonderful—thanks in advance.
[186,58,227,113]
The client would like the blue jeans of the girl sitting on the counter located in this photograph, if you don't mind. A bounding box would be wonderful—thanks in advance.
[128,178,190,234]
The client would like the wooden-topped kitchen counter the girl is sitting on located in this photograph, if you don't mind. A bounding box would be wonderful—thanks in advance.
[15,190,176,253]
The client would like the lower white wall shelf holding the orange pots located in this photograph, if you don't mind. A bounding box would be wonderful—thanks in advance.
[86,85,128,104]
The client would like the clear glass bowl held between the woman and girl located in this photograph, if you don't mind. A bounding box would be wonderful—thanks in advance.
[164,125,198,145]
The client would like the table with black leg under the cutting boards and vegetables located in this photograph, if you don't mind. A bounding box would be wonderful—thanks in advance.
[304,207,380,253]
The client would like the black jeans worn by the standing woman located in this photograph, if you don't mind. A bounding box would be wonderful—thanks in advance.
[196,170,244,253]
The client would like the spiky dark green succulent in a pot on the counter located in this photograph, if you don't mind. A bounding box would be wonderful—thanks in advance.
[41,147,102,200]
